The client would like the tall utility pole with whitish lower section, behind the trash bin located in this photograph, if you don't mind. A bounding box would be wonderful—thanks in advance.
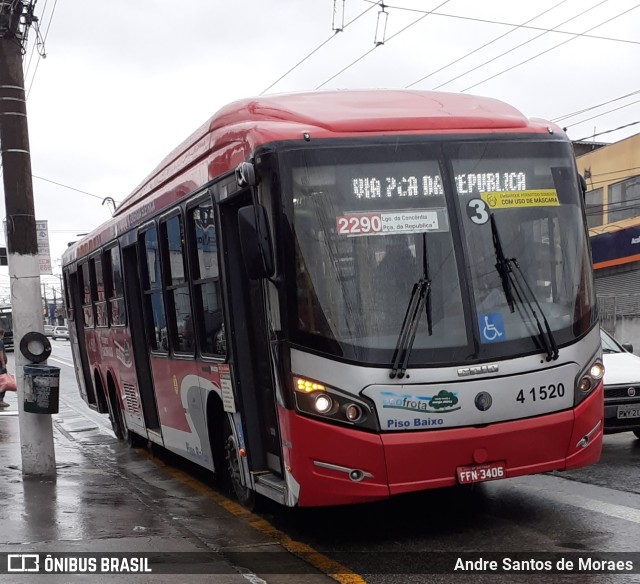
[0,0,56,476]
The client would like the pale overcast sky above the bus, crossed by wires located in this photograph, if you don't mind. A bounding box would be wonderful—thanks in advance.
[0,0,640,299]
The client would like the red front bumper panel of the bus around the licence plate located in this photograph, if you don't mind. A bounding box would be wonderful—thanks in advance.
[280,384,603,506]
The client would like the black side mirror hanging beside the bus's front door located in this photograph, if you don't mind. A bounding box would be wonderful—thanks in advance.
[238,205,274,280]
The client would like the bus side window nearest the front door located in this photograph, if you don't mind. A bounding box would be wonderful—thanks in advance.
[187,200,227,356]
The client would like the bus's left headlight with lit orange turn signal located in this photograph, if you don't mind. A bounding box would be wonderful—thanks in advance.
[293,376,379,430]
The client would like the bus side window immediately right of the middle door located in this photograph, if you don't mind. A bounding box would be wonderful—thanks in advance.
[139,227,169,352]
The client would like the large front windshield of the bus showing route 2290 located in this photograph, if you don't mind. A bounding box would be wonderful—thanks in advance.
[282,140,595,367]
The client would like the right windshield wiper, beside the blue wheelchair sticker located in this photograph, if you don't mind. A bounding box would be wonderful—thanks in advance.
[490,213,559,361]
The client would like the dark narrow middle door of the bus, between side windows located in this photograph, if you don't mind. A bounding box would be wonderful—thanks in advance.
[122,244,161,442]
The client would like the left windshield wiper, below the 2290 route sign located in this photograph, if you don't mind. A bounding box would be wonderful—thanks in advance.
[389,233,433,379]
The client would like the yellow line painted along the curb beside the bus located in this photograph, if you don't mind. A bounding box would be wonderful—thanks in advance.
[138,451,365,584]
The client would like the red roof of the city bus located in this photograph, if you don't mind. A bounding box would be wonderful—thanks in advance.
[64,89,560,259]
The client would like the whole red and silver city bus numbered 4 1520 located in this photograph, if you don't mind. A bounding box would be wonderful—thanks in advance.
[63,90,603,506]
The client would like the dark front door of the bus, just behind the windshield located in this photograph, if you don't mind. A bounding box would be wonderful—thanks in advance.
[219,191,282,475]
